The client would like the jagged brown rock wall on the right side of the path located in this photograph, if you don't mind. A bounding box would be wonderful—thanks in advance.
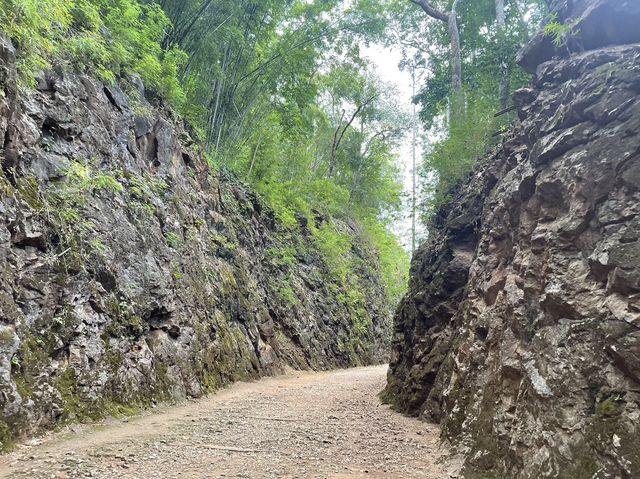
[383,22,640,479]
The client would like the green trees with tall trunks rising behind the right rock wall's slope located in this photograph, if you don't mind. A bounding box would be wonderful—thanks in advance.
[390,0,546,224]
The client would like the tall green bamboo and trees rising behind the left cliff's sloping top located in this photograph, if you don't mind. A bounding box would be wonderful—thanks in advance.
[156,0,406,296]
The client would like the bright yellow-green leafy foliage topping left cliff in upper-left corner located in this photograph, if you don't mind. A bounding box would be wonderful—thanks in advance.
[0,0,187,108]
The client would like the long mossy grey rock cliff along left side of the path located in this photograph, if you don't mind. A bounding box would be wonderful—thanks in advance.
[0,33,391,448]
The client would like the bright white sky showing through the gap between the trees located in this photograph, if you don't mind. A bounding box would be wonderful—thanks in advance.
[362,45,422,251]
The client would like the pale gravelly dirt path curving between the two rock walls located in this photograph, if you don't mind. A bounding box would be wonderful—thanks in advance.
[0,366,453,479]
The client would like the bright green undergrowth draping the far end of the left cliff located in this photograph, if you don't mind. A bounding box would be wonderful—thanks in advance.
[256,190,402,365]
